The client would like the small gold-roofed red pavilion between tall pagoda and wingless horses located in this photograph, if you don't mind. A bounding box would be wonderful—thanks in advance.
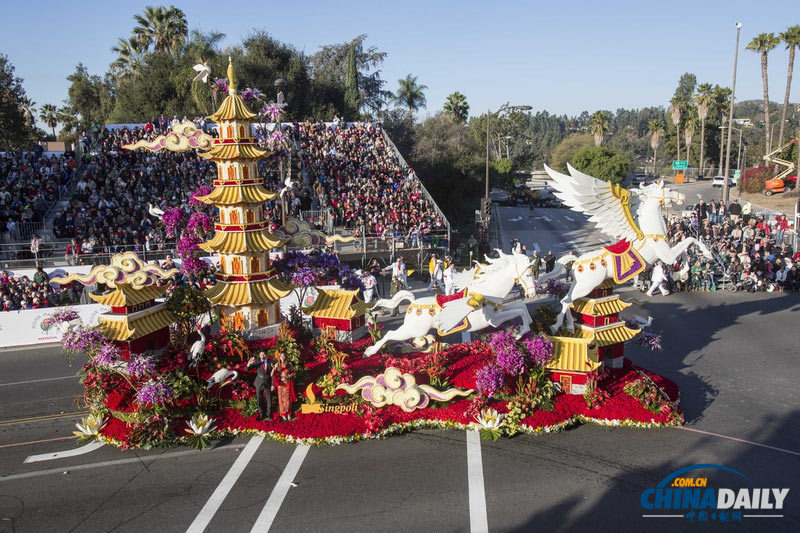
[303,288,370,342]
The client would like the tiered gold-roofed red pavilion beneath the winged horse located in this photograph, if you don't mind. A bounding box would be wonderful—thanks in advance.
[547,280,641,394]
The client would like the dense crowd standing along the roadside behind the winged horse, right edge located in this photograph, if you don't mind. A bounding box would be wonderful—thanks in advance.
[667,200,800,292]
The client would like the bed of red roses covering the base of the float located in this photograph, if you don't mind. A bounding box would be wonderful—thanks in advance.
[89,332,682,448]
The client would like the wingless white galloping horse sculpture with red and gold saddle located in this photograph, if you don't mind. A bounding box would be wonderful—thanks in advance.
[364,250,536,357]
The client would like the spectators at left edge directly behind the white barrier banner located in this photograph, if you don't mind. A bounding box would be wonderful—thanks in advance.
[0,267,83,311]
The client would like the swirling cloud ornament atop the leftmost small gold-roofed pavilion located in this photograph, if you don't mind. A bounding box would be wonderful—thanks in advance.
[50,252,180,289]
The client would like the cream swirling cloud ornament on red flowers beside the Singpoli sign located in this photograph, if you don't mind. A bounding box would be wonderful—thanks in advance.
[336,366,474,413]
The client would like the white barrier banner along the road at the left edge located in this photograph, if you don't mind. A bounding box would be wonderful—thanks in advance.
[0,304,111,349]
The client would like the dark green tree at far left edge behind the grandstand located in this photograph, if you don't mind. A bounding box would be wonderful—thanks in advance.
[0,54,33,151]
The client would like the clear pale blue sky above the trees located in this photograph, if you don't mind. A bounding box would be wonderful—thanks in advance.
[0,0,800,122]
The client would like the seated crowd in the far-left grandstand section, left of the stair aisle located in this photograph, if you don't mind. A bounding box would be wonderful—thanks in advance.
[0,151,77,243]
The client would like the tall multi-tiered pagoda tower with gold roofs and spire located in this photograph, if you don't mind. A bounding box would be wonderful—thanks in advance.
[197,60,293,331]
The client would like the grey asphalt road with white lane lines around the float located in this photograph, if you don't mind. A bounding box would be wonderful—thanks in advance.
[0,210,800,532]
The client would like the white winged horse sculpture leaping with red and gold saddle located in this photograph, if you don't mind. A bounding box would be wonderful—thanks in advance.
[539,165,712,333]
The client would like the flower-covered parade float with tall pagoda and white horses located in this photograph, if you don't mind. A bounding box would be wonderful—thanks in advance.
[63,61,682,448]
